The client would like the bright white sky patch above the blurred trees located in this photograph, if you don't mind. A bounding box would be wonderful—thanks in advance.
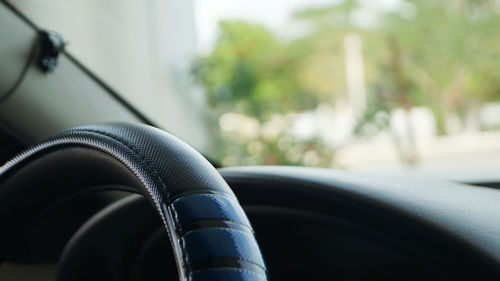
[194,0,401,53]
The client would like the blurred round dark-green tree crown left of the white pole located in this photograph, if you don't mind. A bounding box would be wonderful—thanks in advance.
[193,22,317,120]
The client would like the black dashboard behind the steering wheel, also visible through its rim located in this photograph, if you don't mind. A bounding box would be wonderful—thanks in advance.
[0,167,500,281]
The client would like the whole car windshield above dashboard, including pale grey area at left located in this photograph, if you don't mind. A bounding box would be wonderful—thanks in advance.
[12,0,500,179]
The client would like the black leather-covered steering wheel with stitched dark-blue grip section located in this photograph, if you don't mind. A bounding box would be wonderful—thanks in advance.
[0,123,267,281]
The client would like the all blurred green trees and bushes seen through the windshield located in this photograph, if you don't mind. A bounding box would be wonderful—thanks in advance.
[193,0,500,166]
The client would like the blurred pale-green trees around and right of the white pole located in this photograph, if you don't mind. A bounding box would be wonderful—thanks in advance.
[294,0,500,134]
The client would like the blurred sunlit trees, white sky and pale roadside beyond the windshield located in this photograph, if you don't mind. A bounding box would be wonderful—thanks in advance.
[193,0,500,179]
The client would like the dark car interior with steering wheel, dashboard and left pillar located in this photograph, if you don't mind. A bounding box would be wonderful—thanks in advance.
[0,0,500,281]
